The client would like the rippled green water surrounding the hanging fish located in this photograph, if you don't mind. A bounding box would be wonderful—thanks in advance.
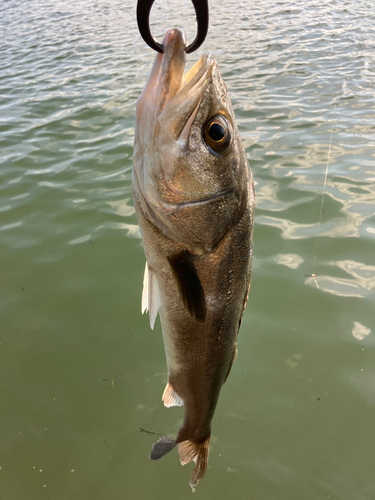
[0,0,375,500]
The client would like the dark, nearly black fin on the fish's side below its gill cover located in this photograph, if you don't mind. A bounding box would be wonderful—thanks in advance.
[168,250,207,321]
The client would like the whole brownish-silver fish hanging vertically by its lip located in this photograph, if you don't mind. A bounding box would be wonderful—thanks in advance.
[132,28,255,491]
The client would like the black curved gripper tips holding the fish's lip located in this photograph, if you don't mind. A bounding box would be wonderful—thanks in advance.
[137,0,208,54]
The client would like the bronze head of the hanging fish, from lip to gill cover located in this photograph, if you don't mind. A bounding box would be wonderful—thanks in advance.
[133,29,250,247]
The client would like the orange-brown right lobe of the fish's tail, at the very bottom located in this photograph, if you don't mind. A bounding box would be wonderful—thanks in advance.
[178,436,210,491]
